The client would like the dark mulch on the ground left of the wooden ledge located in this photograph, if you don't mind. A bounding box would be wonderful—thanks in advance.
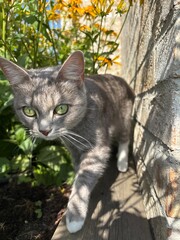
[0,183,70,240]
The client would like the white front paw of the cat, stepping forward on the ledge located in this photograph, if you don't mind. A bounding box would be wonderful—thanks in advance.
[66,210,85,233]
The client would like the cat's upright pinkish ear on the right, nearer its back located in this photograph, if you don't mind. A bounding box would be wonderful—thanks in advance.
[57,51,84,85]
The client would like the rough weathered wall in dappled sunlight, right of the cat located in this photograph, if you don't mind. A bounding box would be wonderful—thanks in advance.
[121,0,180,240]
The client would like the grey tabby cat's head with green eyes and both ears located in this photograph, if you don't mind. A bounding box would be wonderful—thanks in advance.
[0,51,87,140]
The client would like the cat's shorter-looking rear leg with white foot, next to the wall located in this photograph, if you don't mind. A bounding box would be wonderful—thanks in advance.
[117,141,129,172]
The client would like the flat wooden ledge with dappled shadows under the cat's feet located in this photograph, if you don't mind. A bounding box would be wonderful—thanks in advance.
[52,154,152,240]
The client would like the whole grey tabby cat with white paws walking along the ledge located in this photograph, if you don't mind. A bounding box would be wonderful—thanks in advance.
[0,51,134,233]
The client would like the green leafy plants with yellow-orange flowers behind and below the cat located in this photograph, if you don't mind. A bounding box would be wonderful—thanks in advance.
[0,0,143,185]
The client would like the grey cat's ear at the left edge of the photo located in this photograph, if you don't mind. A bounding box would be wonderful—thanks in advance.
[0,57,30,86]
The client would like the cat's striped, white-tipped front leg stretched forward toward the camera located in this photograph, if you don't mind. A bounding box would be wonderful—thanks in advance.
[66,147,110,233]
